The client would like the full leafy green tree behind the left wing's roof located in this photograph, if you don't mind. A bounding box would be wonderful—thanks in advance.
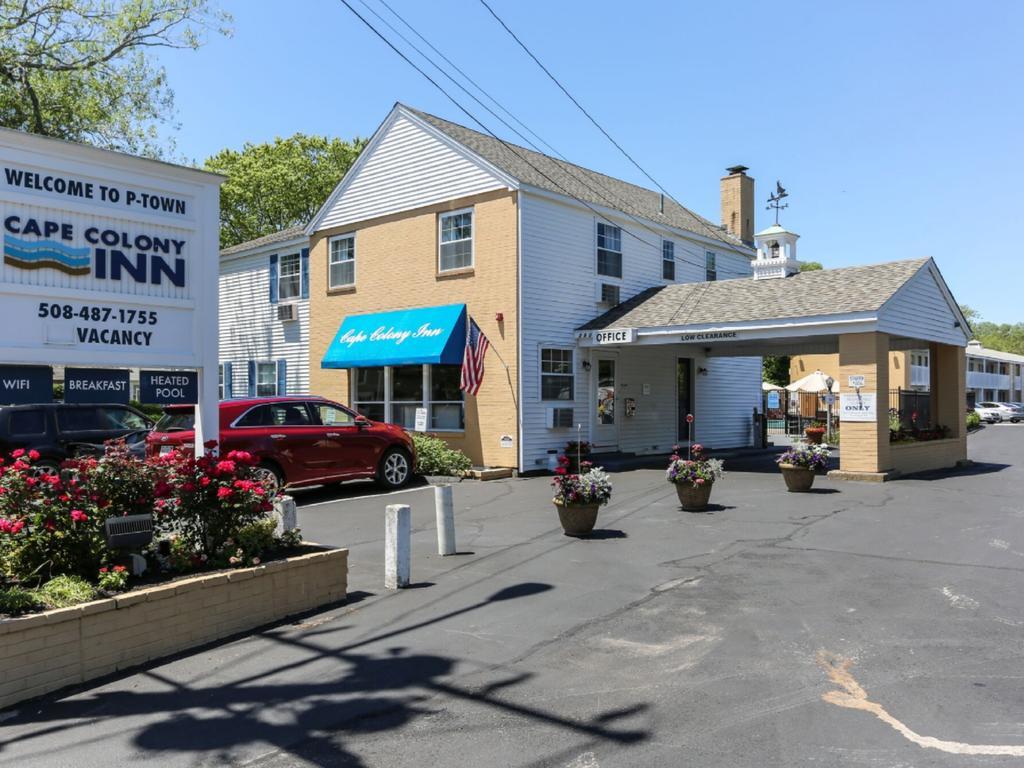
[205,133,367,248]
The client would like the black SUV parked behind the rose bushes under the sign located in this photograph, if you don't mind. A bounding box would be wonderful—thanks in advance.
[0,402,153,470]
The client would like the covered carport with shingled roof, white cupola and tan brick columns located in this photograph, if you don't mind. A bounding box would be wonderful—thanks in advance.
[575,256,970,480]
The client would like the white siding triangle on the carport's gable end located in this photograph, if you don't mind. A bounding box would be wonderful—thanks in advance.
[879,266,967,346]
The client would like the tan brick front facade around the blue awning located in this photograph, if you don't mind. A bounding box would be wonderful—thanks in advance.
[309,190,519,467]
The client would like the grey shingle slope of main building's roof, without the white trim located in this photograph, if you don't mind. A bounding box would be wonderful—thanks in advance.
[402,104,750,249]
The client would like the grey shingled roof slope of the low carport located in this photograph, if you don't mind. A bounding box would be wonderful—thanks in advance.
[577,259,930,331]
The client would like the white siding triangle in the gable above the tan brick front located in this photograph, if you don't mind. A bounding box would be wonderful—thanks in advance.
[316,114,507,229]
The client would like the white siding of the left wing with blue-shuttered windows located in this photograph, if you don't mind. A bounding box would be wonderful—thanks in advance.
[220,239,309,397]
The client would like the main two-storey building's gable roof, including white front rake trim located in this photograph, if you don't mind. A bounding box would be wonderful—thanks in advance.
[306,103,754,249]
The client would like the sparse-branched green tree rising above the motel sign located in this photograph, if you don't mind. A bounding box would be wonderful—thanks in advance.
[0,0,230,157]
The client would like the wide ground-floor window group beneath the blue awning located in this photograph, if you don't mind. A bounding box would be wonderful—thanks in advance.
[352,365,466,432]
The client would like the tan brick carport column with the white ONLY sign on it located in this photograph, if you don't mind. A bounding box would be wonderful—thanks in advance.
[839,333,891,474]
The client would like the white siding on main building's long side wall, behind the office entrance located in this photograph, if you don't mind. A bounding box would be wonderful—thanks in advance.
[519,193,761,471]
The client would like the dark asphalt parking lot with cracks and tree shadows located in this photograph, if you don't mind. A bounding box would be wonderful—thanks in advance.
[0,425,1024,768]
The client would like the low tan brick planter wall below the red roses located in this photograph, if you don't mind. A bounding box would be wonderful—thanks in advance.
[0,549,348,708]
